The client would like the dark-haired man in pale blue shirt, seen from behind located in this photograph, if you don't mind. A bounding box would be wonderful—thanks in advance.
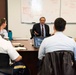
[38,18,76,60]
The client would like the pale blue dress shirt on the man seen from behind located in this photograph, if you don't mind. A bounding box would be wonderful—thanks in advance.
[38,32,76,60]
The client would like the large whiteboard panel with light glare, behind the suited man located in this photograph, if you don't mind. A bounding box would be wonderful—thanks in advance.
[21,0,60,23]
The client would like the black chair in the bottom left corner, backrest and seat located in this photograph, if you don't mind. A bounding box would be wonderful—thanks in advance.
[0,53,13,75]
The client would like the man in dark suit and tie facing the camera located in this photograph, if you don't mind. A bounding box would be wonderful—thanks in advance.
[31,17,51,38]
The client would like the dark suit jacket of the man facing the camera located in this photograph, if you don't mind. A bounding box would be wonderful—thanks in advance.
[32,23,50,38]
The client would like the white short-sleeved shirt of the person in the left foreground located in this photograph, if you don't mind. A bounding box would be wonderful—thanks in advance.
[0,36,19,60]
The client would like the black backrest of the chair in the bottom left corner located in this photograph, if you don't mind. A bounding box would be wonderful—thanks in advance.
[0,53,9,68]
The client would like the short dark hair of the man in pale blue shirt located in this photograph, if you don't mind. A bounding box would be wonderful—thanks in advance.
[54,18,66,31]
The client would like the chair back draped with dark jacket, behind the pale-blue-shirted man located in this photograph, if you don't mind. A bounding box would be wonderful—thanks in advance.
[38,51,76,75]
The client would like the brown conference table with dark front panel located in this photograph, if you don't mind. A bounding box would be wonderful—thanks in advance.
[12,39,38,75]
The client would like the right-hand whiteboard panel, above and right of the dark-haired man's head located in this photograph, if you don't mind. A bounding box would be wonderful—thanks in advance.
[61,0,76,23]
